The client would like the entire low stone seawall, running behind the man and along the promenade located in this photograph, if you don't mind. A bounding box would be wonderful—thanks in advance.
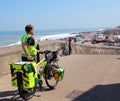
[0,41,120,77]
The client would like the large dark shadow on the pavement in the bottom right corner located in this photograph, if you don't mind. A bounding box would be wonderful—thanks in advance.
[72,84,120,101]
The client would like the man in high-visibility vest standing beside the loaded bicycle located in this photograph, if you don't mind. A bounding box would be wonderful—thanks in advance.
[21,25,43,91]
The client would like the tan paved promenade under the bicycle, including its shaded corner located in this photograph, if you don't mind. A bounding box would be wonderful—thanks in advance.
[0,55,120,101]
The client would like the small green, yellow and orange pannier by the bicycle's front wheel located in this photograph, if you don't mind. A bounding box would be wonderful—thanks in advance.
[54,67,65,81]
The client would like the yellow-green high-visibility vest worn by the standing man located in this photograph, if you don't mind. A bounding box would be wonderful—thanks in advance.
[21,34,37,57]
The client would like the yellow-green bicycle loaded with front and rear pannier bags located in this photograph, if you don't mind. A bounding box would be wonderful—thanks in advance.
[10,48,64,101]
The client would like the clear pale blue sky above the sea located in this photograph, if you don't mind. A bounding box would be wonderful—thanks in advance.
[0,0,120,30]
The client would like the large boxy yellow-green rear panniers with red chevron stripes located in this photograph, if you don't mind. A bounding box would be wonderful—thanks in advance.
[10,62,38,89]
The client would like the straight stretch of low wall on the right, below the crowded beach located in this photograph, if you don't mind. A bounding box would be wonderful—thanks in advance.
[72,44,120,55]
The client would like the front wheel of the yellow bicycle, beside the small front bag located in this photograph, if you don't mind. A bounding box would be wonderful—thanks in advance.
[45,65,58,89]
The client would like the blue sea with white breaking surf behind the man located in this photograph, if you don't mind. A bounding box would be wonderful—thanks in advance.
[0,28,97,47]
